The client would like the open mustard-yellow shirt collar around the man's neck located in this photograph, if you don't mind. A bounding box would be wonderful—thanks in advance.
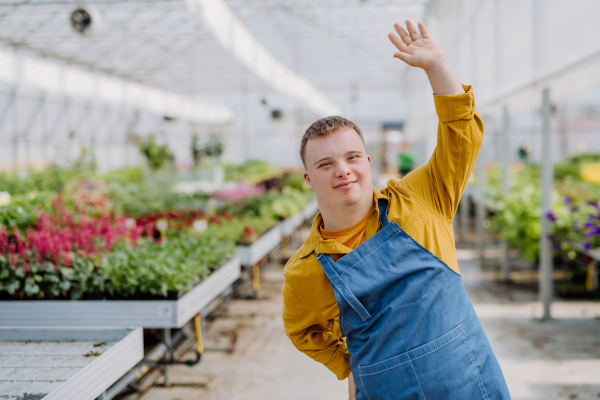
[298,188,387,258]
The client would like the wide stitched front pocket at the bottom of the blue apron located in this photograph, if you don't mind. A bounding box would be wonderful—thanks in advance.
[358,325,488,400]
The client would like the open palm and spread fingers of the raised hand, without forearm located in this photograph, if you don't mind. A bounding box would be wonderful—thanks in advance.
[388,20,446,70]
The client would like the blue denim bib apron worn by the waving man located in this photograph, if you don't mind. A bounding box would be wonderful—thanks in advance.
[317,200,510,400]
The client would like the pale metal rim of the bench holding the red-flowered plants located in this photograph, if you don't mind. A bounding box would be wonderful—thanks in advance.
[0,258,240,328]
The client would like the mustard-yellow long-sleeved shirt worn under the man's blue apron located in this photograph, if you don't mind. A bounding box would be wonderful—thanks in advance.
[283,85,483,379]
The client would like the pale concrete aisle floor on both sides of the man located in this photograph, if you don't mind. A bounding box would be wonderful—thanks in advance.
[142,245,600,400]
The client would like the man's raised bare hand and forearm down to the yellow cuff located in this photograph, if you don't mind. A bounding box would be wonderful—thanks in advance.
[388,20,464,95]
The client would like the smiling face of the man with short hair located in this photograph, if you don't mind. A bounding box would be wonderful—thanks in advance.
[304,128,373,207]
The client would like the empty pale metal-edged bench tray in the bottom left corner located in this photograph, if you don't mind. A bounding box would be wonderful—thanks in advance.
[0,327,144,400]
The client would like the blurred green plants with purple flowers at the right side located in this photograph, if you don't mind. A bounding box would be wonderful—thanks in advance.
[485,153,600,294]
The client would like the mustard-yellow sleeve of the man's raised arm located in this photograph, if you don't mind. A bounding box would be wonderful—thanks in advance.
[400,85,483,219]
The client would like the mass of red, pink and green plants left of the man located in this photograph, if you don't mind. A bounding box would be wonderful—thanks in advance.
[0,159,313,299]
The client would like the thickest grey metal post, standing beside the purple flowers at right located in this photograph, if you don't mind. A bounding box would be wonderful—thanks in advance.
[540,88,554,320]
